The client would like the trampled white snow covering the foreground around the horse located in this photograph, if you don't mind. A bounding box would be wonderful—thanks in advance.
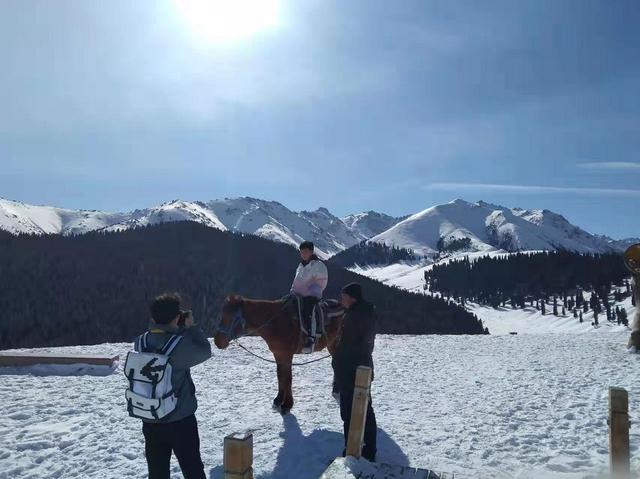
[0,332,640,479]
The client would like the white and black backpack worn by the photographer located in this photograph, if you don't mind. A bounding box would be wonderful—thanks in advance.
[124,331,182,420]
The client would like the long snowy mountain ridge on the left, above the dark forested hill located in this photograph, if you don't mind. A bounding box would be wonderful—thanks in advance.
[0,197,368,257]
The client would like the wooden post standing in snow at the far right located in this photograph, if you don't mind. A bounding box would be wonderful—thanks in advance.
[609,387,631,479]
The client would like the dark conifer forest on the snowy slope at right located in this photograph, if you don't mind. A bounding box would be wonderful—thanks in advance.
[425,251,635,325]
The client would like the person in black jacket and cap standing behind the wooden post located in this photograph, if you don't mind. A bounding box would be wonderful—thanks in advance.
[332,283,378,462]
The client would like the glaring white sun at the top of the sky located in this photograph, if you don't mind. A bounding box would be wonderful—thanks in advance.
[174,0,281,43]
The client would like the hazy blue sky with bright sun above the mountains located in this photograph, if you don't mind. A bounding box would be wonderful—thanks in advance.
[0,0,640,238]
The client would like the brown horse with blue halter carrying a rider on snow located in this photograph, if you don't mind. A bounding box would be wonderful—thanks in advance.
[214,295,344,414]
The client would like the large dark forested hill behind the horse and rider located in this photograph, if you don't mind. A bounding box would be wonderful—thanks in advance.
[0,222,484,348]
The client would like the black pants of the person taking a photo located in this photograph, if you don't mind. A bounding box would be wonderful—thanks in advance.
[142,415,206,479]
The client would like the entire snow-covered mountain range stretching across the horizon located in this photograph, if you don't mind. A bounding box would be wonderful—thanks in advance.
[0,197,640,257]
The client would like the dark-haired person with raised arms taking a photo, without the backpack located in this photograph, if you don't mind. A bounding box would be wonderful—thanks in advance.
[137,293,211,479]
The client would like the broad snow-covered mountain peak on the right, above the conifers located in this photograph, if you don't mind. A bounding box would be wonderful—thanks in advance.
[370,199,626,255]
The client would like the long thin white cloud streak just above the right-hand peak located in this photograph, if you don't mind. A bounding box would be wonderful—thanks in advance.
[425,183,640,198]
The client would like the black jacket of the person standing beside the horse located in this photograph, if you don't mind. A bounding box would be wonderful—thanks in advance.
[331,300,376,389]
